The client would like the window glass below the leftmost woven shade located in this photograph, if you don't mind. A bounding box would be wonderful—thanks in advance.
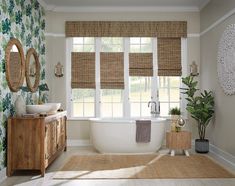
[72,89,95,117]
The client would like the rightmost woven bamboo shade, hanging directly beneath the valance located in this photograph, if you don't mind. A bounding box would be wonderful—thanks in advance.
[157,38,182,76]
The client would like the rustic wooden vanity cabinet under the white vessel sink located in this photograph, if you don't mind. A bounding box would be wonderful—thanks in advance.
[7,112,67,176]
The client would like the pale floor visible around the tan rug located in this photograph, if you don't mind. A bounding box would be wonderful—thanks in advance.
[0,147,235,186]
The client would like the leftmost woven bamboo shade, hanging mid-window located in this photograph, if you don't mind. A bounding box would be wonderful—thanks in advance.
[71,52,95,88]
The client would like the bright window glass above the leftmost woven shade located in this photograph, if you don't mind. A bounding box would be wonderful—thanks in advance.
[73,37,95,52]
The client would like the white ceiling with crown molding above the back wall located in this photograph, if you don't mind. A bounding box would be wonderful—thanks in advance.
[38,0,210,12]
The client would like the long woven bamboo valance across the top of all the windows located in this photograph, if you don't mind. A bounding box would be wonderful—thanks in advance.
[65,21,187,38]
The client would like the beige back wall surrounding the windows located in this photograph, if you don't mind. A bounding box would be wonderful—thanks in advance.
[46,12,200,140]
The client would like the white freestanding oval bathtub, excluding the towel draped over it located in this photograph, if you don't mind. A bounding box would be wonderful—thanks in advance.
[90,118,166,153]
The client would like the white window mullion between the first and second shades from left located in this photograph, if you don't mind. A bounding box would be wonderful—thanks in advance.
[95,37,101,117]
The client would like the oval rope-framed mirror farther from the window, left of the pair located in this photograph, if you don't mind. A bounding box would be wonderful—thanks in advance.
[5,38,25,92]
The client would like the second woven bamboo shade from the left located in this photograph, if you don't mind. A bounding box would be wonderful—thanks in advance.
[100,52,124,89]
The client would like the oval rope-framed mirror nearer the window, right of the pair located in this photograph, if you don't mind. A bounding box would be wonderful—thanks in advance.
[25,48,40,92]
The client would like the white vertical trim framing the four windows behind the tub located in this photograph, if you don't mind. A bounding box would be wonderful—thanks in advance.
[65,37,188,121]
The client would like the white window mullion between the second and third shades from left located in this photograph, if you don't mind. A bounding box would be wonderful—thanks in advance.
[123,37,130,118]
